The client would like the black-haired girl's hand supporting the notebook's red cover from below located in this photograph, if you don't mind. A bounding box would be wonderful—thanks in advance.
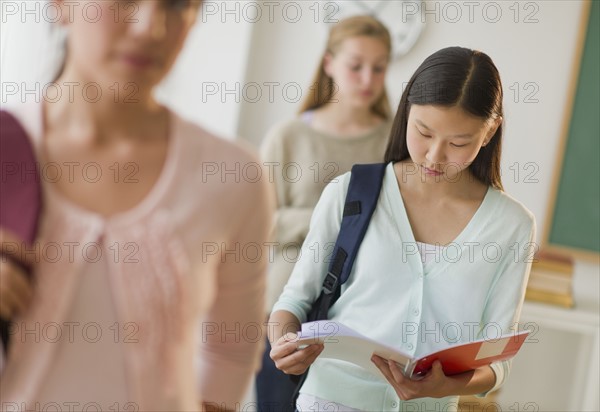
[371,355,450,401]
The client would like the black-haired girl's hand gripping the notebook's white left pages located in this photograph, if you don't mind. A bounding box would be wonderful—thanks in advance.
[269,333,325,375]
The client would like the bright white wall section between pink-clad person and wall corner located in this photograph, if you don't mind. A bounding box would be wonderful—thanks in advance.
[158,1,253,139]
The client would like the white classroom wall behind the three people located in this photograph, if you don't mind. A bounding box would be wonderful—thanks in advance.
[0,0,583,229]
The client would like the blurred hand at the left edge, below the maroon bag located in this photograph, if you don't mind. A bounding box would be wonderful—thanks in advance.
[0,229,33,320]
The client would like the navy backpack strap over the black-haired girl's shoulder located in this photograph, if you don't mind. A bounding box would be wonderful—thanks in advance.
[308,163,387,321]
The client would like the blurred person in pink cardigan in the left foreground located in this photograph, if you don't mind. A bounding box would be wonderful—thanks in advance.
[0,0,272,412]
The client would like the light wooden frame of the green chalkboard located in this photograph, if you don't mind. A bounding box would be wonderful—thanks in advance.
[541,0,600,263]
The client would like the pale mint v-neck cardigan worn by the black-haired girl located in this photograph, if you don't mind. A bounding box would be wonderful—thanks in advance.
[273,163,535,411]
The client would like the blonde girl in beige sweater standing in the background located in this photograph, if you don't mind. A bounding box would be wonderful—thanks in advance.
[257,16,391,411]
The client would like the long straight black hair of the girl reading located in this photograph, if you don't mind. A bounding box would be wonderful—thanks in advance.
[385,47,504,190]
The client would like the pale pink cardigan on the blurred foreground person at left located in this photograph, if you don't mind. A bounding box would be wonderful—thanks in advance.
[0,104,273,411]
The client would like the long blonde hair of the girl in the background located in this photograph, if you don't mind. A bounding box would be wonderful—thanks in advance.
[299,16,392,120]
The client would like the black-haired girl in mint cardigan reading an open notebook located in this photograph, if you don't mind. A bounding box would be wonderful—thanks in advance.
[269,47,535,411]
